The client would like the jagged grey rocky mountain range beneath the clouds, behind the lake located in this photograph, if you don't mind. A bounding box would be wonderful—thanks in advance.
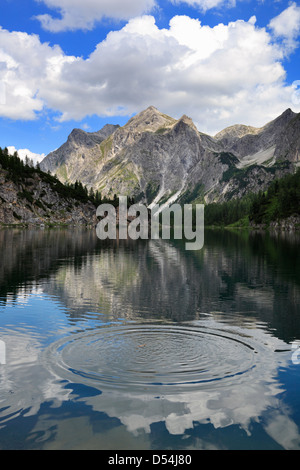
[41,106,300,207]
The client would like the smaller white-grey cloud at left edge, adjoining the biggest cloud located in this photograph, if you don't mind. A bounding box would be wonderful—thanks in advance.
[0,27,74,120]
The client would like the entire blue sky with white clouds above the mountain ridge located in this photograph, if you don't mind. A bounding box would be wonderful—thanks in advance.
[0,0,300,158]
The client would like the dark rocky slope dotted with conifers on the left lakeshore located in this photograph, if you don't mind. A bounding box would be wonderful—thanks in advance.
[0,148,101,225]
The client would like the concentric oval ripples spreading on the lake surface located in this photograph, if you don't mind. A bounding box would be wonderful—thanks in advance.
[47,323,257,393]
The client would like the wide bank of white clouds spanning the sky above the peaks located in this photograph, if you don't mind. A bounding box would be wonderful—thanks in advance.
[0,6,300,134]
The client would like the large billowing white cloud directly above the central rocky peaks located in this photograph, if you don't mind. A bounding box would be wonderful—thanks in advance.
[45,12,293,132]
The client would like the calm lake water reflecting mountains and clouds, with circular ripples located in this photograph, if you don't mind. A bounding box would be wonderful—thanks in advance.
[0,229,300,450]
